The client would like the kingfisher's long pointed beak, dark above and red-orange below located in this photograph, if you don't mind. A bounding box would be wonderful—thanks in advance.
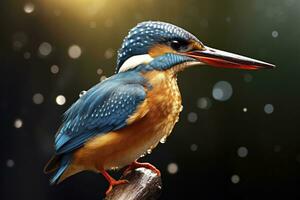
[185,47,275,70]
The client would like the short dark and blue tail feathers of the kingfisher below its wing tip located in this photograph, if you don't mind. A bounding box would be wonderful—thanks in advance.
[44,154,72,185]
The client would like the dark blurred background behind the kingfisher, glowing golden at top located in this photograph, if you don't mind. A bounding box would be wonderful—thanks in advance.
[0,0,300,200]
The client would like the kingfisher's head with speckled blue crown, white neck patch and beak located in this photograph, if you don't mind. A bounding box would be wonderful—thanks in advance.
[116,21,275,73]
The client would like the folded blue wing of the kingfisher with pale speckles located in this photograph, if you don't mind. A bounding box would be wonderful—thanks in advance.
[55,72,146,155]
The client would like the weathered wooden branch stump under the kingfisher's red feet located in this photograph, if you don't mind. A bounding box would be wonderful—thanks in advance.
[105,168,162,200]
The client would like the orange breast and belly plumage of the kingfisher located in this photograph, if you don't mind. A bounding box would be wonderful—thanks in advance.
[73,71,182,170]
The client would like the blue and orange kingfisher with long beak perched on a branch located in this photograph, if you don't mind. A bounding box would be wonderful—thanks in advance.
[44,21,275,194]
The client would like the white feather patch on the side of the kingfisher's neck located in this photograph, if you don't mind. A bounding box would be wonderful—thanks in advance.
[119,54,153,72]
